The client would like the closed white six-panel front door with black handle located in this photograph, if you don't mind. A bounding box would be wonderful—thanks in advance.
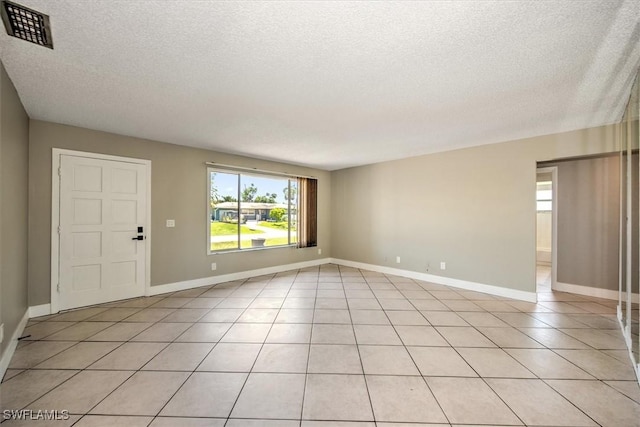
[56,154,149,310]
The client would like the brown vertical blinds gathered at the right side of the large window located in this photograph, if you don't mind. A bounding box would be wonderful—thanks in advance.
[298,178,318,248]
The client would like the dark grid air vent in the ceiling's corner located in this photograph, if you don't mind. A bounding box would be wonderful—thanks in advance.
[0,1,53,49]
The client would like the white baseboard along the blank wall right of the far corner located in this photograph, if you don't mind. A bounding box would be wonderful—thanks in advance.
[331,258,537,302]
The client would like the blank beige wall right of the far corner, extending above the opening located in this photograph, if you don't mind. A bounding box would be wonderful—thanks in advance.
[331,126,617,292]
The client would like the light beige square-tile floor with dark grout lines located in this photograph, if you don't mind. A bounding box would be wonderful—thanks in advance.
[0,265,640,427]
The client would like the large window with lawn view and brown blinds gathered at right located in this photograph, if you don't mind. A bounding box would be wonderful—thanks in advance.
[208,168,317,252]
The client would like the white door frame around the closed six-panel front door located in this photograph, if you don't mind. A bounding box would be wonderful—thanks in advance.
[51,148,151,314]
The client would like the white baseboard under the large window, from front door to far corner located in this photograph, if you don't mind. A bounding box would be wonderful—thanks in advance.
[149,258,330,295]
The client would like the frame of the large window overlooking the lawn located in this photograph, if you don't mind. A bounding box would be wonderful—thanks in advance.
[206,165,300,255]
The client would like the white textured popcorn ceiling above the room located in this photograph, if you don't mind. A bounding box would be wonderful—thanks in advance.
[0,0,640,170]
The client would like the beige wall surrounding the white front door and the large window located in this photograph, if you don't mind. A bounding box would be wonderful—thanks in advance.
[29,120,331,306]
